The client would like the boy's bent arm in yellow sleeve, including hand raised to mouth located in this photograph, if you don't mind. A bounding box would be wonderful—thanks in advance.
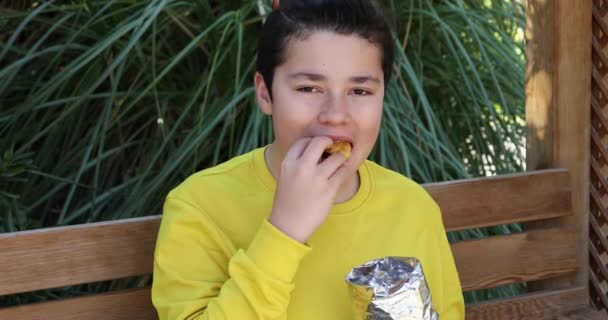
[152,137,356,320]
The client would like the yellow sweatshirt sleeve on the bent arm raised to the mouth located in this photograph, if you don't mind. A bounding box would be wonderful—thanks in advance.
[152,195,310,320]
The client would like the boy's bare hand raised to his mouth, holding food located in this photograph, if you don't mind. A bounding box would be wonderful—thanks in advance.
[268,137,354,243]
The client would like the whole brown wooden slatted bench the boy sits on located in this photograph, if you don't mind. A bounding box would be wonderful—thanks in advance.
[0,169,608,320]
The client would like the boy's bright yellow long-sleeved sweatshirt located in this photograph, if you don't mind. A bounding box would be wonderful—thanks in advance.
[152,148,464,320]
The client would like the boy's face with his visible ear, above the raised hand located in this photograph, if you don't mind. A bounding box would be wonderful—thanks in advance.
[255,31,384,170]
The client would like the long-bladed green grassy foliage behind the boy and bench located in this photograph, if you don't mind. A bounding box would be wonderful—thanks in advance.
[0,0,524,300]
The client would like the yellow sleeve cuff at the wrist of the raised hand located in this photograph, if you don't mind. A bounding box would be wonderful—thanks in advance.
[247,220,311,282]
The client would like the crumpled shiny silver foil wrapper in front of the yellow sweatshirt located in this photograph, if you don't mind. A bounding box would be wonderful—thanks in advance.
[346,257,439,320]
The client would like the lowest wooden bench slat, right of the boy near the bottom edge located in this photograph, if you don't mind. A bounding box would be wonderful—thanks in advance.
[466,287,588,320]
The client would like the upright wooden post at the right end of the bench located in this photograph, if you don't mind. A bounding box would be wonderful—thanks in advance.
[526,0,592,296]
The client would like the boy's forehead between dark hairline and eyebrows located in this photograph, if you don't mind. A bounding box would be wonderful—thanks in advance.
[276,31,382,78]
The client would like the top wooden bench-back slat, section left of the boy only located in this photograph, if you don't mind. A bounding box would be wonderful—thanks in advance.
[0,216,160,295]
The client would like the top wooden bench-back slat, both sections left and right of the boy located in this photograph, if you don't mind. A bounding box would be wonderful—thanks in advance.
[0,169,570,295]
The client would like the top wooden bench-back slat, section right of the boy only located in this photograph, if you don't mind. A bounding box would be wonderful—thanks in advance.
[425,169,571,231]
